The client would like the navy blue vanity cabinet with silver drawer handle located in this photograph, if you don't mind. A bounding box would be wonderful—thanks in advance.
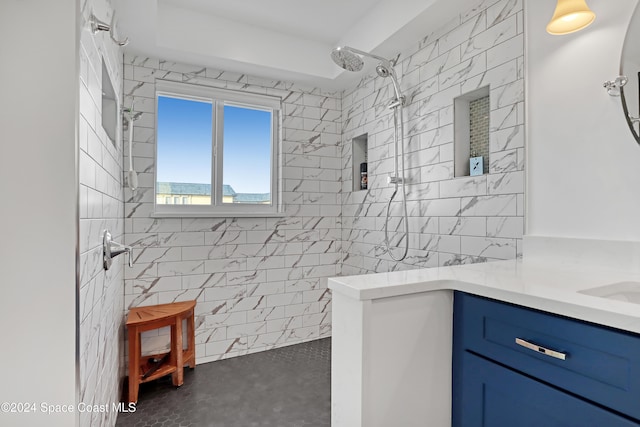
[452,292,640,427]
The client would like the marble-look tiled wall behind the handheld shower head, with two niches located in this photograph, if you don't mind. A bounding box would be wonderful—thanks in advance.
[342,0,524,274]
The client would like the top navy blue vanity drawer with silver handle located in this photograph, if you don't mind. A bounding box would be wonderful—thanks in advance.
[454,292,640,420]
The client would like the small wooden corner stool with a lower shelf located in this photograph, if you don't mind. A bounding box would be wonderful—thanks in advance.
[127,301,196,402]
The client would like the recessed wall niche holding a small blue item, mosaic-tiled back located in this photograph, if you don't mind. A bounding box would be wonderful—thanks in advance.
[453,86,490,177]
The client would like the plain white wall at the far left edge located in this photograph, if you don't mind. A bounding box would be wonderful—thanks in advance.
[0,0,79,427]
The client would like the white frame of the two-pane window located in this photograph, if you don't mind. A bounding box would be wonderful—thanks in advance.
[152,80,284,217]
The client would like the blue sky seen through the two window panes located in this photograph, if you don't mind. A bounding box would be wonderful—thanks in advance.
[157,96,272,193]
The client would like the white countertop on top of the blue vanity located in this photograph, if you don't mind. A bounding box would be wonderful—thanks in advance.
[329,260,640,333]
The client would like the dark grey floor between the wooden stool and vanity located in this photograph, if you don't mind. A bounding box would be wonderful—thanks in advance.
[116,338,331,427]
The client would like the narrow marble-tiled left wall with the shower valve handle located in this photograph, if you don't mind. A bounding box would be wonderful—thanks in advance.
[79,0,124,426]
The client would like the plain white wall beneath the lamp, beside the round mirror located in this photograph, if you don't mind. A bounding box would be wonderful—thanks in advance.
[525,0,640,242]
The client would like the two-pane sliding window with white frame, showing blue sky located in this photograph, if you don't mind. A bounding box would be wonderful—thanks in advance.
[155,81,281,216]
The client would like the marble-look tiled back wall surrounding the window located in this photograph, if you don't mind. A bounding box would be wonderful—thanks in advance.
[124,55,342,363]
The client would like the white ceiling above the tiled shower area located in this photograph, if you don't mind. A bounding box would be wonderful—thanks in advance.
[115,0,479,89]
